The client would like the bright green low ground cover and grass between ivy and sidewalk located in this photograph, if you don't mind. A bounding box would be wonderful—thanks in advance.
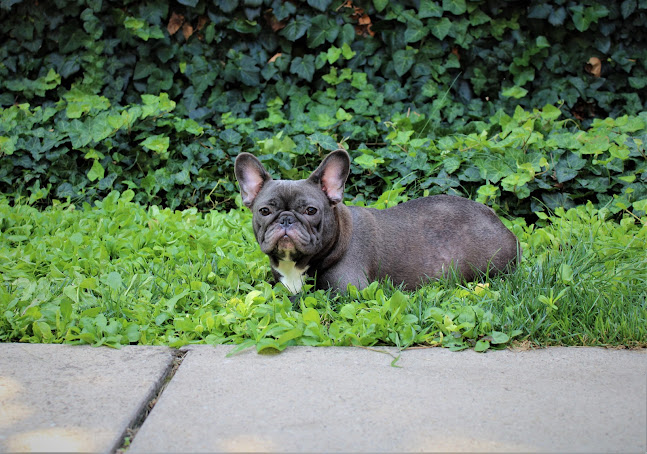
[0,191,647,351]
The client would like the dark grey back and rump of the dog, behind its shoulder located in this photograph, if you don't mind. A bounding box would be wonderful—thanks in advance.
[351,195,520,288]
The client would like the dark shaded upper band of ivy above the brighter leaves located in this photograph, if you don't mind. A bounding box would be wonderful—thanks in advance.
[0,0,647,119]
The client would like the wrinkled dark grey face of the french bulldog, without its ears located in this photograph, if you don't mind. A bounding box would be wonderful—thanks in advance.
[250,180,331,262]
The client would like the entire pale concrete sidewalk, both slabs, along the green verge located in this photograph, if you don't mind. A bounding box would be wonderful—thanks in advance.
[0,344,647,453]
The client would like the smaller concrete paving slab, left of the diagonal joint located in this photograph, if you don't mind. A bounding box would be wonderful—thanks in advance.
[0,344,174,452]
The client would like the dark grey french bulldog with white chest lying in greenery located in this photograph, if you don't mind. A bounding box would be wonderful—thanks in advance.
[235,149,521,294]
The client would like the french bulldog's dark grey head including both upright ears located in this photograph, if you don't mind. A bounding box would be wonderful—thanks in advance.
[235,150,350,262]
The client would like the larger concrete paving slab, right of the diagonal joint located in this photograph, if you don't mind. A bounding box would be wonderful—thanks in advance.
[129,346,647,453]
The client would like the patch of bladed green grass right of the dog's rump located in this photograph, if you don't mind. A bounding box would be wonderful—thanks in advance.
[491,206,647,346]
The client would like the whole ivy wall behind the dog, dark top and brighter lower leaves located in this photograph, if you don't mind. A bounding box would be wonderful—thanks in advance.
[0,0,647,215]
